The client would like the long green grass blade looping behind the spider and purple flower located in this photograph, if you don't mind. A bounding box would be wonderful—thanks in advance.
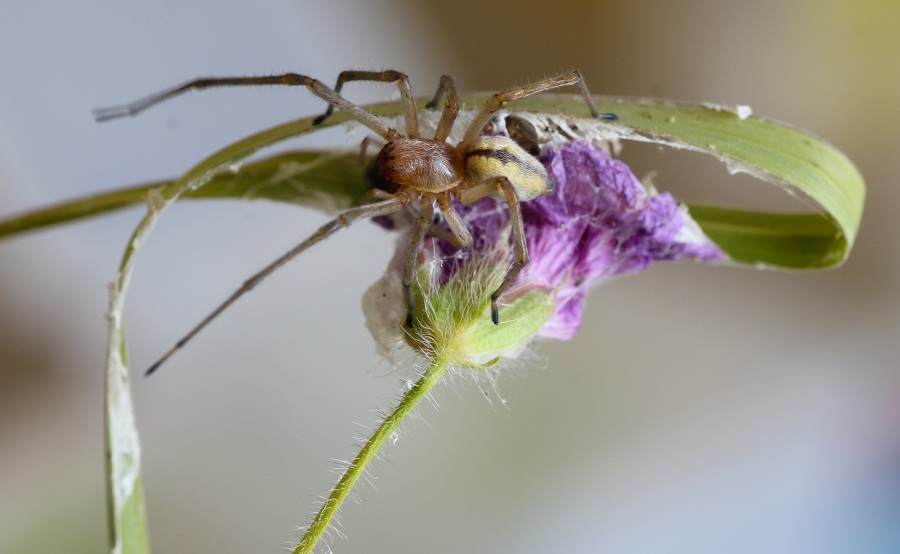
[0,95,865,268]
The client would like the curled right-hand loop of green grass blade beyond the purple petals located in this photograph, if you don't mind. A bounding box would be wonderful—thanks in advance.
[486,95,865,269]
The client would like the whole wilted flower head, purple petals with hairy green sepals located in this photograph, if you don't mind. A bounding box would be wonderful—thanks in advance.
[366,141,724,365]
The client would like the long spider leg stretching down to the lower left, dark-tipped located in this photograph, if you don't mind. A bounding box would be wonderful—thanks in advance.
[144,196,408,375]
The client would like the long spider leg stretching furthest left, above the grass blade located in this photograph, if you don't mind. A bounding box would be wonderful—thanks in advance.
[92,73,400,140]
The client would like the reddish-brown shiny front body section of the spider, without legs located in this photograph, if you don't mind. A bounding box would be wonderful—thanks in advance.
[375,138,463,192]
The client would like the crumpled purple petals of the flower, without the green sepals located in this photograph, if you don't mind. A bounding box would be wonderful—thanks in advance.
[432,141,724,339]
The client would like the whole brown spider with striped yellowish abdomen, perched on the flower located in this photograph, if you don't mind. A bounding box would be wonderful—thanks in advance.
[93,70,617,375]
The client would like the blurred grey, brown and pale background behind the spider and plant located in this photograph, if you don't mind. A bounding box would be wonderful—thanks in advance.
[0,0,900,553]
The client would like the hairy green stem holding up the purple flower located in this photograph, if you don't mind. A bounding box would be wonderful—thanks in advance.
[294,352,450,554]
